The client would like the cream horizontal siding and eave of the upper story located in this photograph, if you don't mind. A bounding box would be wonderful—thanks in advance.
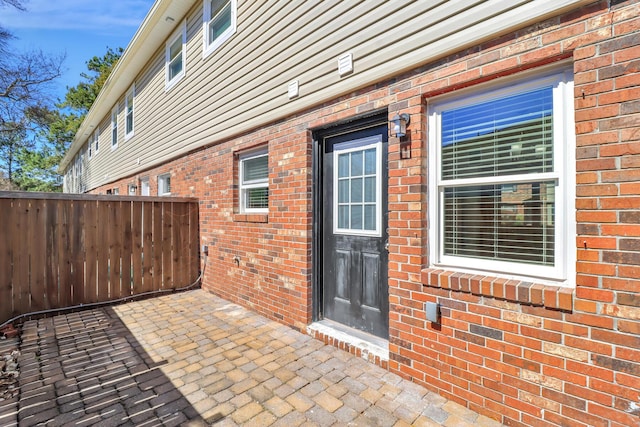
[61,0,586,189]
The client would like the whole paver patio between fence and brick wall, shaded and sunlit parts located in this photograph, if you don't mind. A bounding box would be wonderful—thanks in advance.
[0,290,500,426]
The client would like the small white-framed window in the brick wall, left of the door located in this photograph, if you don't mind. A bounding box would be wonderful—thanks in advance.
[239,150,269,213]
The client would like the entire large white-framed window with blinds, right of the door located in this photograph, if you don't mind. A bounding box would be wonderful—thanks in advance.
[429,72,575,281]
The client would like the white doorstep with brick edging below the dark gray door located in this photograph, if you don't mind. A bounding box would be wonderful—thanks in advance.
[307,319,389,361]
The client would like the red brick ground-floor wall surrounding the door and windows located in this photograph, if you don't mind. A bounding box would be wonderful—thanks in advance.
[98,1,640,427]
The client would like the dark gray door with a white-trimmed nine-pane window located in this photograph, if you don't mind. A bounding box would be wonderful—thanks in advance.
[322,122,389,338]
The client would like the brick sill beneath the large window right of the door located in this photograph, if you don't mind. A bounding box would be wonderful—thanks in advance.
[421,268,574,311]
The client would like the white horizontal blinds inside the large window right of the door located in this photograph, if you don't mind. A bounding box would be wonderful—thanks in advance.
[441,87,555,265]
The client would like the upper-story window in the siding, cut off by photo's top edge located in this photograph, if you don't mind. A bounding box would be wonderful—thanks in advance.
[203,0,237,57]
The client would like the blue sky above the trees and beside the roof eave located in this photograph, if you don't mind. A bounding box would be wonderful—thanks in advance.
[0,0,154,102]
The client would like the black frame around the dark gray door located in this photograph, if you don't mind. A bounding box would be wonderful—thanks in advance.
[311,108,389,322]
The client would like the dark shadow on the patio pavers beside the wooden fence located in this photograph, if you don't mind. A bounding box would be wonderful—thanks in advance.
[18,307,211,426]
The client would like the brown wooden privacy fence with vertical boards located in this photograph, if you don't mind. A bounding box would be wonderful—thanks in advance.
[0,192,200,323]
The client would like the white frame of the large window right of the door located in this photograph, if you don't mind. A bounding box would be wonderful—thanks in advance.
[427,68,576,284]
